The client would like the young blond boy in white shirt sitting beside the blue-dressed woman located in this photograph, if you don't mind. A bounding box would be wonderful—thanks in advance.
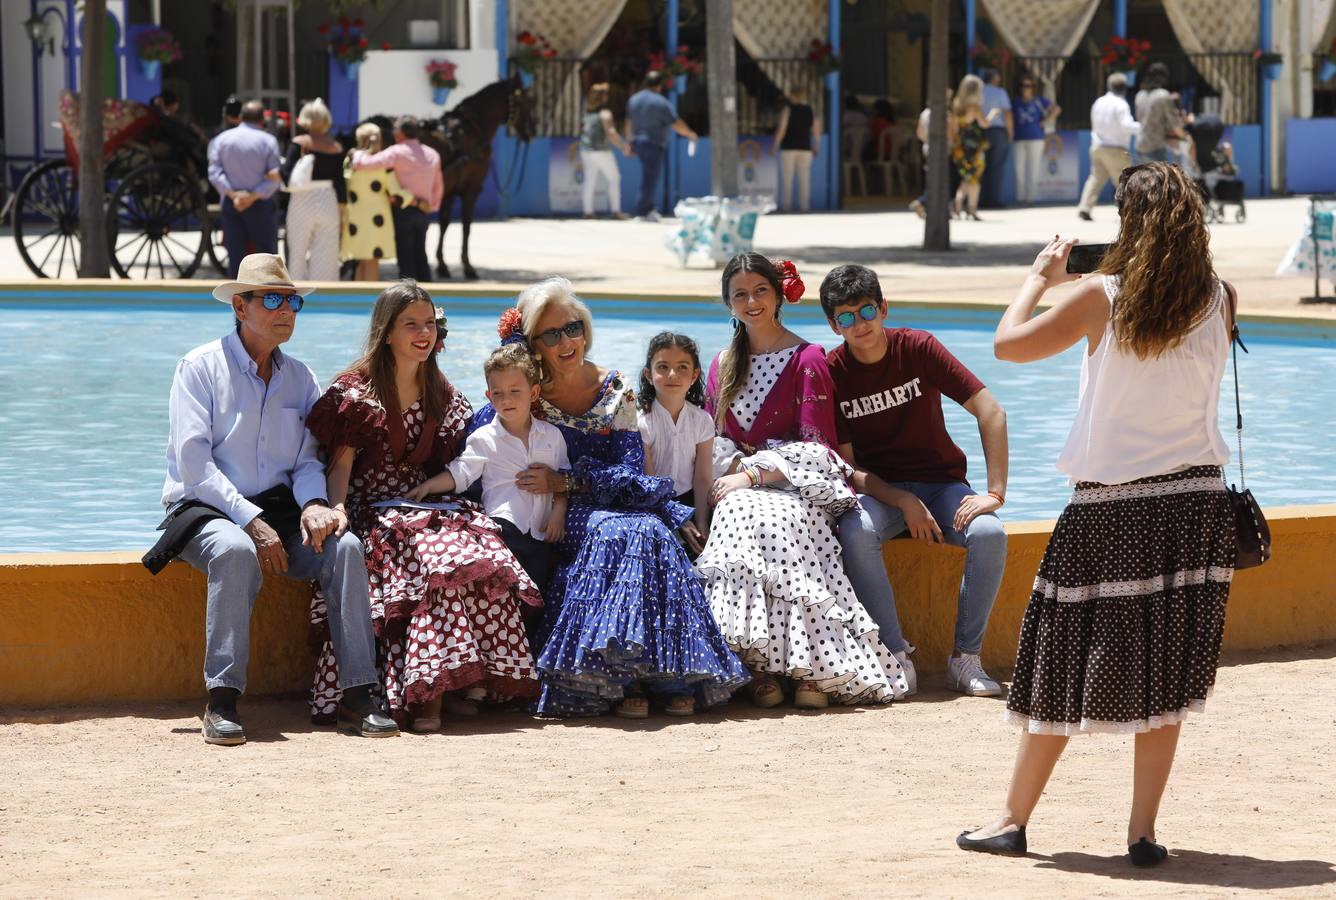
[409,345,570,590]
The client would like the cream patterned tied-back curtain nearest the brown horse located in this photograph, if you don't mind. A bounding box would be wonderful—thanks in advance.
[510,0,627,135]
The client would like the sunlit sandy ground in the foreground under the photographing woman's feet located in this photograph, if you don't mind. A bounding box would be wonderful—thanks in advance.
[0,645,1336,897]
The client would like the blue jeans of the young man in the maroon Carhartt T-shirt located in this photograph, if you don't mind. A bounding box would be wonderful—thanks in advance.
[839,481,1006,653]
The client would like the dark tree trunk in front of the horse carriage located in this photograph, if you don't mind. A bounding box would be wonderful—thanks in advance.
[79,0,111,278]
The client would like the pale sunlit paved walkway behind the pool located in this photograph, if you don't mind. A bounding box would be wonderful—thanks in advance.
[0,198,1336,319]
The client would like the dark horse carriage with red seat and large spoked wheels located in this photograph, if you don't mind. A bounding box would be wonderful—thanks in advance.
[12,92,222,278]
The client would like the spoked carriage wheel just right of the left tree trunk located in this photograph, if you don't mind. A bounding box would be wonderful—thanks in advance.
[107,163,208,278]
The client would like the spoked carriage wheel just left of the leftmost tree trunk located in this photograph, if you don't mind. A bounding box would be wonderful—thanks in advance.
[13,159,80,278]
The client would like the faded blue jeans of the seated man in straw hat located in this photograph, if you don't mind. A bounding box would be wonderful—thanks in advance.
[180,518,377,692]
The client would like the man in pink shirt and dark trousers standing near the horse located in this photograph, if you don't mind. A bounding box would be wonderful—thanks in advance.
[353,116,445,282]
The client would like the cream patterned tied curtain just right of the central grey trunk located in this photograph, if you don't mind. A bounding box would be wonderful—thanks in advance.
[733,0,822,122]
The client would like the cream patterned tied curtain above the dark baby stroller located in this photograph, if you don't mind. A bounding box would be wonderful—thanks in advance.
[1165,0,1255,123]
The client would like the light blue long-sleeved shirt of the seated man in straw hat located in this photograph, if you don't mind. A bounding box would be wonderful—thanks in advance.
[163,332,327,526]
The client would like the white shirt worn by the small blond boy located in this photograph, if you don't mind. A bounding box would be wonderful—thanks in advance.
[449,417,570,541]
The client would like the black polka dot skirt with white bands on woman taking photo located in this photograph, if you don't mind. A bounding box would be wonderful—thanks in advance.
[1006,466,1237,734]
